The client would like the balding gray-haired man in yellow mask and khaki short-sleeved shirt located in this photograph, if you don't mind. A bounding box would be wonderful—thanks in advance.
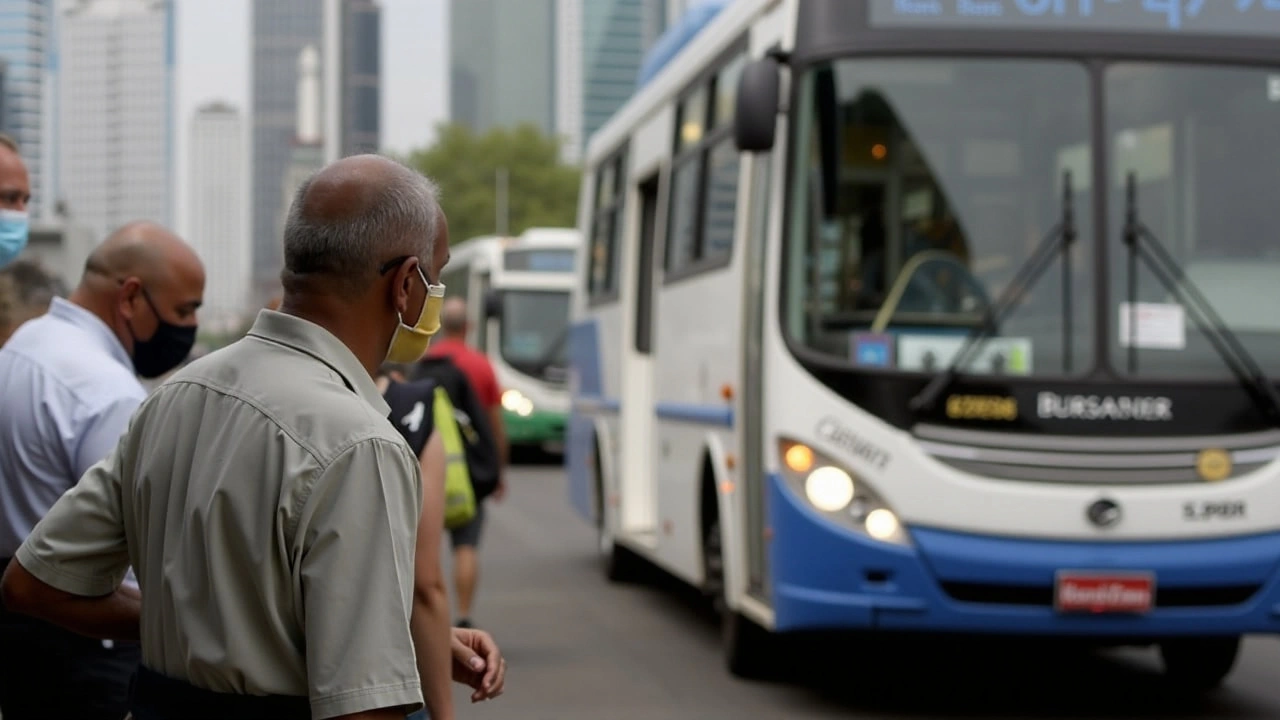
[0,155,504,720]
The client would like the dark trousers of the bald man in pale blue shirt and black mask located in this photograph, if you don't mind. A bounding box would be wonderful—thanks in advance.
[0,610,141,720]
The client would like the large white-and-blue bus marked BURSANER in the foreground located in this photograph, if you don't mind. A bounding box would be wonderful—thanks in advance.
[566,0,1280,688]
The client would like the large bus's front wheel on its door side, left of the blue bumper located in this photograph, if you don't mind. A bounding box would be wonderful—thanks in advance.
[703,512,778,679]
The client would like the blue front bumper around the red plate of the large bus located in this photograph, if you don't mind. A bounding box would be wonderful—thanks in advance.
[768,475,1280,638]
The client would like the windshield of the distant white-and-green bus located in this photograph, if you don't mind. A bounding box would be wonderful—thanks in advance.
[499,290,570,377]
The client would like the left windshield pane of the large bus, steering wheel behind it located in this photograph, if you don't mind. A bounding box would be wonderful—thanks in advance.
[785,59,1094,374]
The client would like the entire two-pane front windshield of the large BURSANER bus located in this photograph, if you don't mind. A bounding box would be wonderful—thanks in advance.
[783,58,1280,379]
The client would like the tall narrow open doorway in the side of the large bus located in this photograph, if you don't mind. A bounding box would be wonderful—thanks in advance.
[620,173,659,541]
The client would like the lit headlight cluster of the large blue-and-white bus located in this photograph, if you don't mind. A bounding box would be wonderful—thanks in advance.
[780,441,911,544]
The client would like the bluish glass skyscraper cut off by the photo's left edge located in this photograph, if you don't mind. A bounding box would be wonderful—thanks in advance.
[0,0,54,218]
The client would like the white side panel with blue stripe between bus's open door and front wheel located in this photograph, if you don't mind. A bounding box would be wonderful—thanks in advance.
[654,263,742,583]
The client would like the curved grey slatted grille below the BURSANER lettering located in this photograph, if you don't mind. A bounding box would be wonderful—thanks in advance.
[913,424,1280,486]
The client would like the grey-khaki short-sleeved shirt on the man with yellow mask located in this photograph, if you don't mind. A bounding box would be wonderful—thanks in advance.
[17,310,422,717]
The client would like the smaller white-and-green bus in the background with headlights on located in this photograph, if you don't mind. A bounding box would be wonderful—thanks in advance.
[442,228,581,454]
